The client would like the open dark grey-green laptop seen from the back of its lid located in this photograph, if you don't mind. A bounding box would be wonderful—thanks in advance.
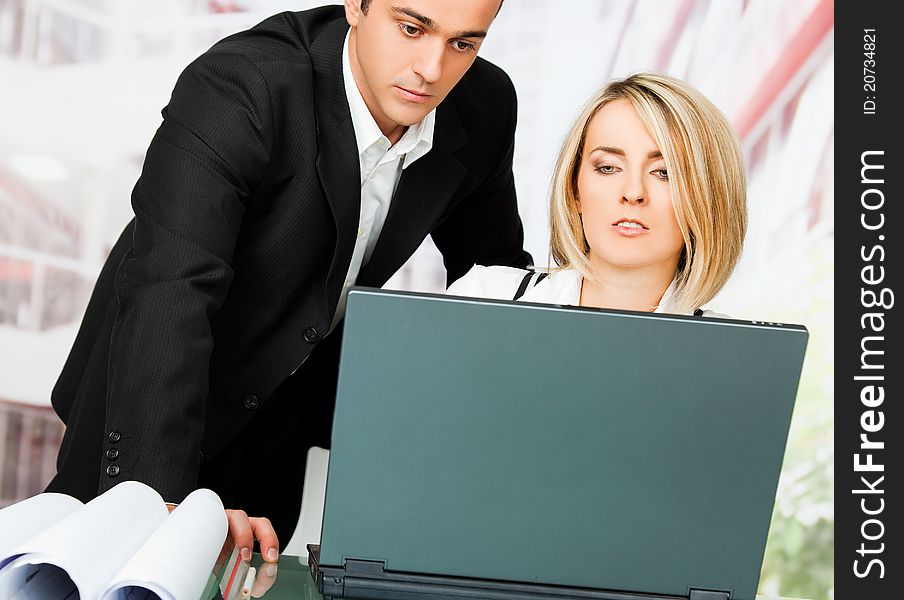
[309,288,808,600]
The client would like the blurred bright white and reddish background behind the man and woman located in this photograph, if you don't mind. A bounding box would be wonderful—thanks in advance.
[0,0,834,600]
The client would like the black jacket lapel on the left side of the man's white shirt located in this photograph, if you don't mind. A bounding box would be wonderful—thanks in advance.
[310,19,361,306]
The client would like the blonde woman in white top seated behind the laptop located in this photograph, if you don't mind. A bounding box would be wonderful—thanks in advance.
[448,73,747,314]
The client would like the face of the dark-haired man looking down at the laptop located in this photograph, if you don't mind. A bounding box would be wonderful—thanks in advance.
[345,0,500,139]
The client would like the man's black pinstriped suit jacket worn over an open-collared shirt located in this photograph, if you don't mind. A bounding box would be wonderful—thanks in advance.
[50,7,530,501]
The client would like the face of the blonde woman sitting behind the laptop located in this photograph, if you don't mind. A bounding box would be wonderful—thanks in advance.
[577,99,684,276]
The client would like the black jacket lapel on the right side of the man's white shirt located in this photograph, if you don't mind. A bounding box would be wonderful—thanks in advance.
[357,98,468,286]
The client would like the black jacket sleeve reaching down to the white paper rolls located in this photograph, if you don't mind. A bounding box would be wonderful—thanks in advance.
[98,52,272,502]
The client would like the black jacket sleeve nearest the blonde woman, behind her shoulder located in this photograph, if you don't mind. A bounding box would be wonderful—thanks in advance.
[432,71,533,286]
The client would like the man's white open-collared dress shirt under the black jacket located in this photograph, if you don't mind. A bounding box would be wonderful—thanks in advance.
[330,34,436,331]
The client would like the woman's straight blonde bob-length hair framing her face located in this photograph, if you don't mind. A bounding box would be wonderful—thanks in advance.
[549,73,747,312]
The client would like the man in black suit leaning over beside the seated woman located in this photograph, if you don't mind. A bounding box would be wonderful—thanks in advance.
[48,0,530,559]
